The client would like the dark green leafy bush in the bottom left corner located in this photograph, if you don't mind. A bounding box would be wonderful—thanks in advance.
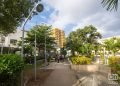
[0,54,24,86]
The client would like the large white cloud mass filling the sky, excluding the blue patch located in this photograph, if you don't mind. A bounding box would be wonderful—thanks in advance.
[44,0,120,36]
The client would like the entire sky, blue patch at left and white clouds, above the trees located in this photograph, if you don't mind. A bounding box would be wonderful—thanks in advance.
[25,0,120,38]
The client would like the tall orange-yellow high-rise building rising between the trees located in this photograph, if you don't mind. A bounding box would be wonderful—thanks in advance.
[51,28,65,48]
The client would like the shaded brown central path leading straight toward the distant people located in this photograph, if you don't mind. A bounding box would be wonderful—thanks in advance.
[41,62,76,86]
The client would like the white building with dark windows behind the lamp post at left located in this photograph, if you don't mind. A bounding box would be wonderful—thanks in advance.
[0,29,27,48]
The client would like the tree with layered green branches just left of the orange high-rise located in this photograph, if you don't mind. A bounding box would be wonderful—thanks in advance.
[25,24,55,55]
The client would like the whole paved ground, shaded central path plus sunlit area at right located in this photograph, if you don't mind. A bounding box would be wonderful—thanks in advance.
[41,62,120,86]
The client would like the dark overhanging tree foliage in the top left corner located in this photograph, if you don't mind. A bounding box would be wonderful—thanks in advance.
[0,0,43,34]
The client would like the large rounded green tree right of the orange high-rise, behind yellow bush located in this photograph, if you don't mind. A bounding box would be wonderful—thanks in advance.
[67,25,102,57]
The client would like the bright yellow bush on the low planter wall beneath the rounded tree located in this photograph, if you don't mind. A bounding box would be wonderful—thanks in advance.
[71,56,91,65]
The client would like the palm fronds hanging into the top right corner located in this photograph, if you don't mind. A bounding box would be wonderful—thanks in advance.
[102,0,120,11]
